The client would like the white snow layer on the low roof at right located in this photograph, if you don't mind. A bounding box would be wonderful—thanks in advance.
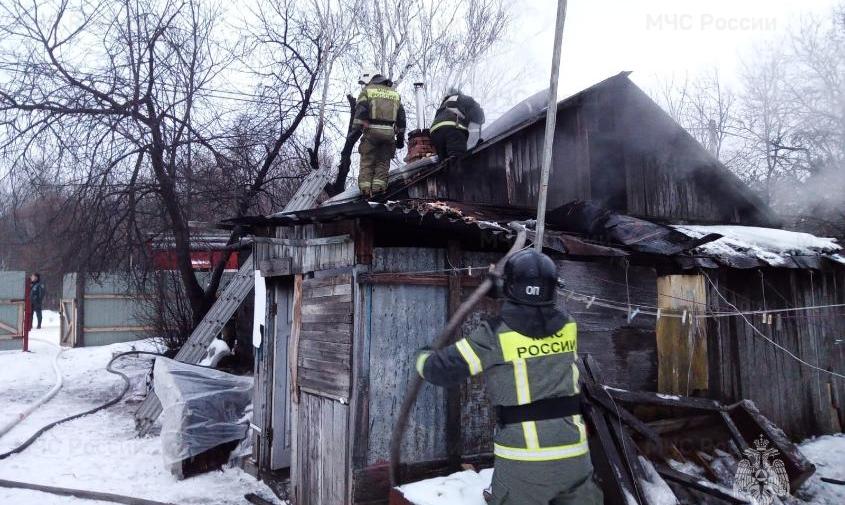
[673,225,842,266]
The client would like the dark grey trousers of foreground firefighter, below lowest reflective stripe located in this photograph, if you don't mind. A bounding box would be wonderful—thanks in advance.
[490,454,604,505]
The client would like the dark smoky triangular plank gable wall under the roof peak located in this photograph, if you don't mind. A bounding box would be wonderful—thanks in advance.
[409,78,773,225]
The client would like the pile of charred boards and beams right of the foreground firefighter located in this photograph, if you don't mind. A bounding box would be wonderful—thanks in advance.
[580,355,815,505]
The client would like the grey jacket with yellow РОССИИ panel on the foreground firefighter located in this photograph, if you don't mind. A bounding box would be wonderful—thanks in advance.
[416,315,589,461]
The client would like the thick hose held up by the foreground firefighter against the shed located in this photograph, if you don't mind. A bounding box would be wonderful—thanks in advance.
[390,228,526,486]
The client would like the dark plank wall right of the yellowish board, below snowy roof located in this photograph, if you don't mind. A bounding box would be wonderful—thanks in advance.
[708,269,845,440]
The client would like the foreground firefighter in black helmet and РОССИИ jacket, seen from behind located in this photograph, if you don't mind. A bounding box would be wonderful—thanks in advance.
[416,249,602,505]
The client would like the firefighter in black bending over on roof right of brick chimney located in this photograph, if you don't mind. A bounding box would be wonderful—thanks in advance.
[429,88,484,161]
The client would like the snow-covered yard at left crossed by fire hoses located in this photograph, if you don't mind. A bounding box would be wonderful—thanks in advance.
[0,312,280,505]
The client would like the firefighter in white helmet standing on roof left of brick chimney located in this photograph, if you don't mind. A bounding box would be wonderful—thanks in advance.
[354,74,406,198]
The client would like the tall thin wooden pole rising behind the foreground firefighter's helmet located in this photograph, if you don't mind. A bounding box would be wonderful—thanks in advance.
[534,0,566,252]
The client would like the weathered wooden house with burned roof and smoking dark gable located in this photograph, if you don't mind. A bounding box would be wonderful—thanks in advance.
[232,73,845,505]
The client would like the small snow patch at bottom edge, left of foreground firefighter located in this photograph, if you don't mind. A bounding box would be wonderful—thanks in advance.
[399,468,493,505]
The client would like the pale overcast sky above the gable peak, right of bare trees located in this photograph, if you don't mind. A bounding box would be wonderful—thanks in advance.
[506,0,836,102]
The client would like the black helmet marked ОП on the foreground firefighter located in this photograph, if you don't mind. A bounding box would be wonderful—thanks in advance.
[504,249,557,305]
